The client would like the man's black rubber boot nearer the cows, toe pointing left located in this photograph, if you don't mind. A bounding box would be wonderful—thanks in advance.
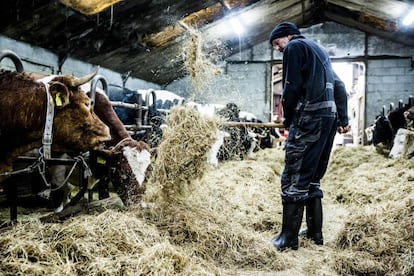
[272,201,304,251]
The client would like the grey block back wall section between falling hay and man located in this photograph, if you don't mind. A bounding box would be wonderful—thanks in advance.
[164,37,271,122]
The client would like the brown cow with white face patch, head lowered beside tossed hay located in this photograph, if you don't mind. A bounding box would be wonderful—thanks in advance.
[50,88,150,209]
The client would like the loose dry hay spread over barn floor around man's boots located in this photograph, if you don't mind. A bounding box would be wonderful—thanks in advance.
[0,135,414,275]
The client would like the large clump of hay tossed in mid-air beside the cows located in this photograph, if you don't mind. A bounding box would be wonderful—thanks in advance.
[147,106,218,205]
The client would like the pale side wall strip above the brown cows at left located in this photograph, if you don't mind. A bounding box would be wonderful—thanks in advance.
[0,35,160,89]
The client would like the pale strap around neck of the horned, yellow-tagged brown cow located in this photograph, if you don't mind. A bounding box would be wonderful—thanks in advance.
[38,78,55,159]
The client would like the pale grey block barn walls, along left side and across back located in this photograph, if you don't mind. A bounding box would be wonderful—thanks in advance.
[0,17,414,126]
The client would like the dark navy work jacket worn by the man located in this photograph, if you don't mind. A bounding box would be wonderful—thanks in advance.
[282,36,348,127]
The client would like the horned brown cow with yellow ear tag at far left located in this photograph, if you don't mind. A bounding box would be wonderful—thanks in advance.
[0,71,111,173]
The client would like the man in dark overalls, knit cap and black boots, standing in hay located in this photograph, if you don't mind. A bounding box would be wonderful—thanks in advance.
[269,22,348,250]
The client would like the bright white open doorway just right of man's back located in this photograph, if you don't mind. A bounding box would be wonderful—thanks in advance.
[332,61,366,145]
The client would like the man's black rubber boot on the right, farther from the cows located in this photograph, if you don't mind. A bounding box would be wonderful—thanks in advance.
[300,198,323,245]
